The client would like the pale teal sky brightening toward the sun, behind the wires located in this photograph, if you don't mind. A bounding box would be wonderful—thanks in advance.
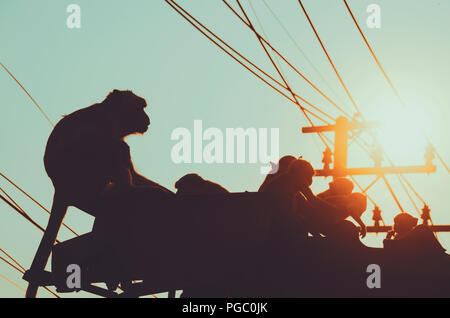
[0,0,450,297]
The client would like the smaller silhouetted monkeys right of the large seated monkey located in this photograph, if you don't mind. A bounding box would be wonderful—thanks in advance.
[175,155,445,254]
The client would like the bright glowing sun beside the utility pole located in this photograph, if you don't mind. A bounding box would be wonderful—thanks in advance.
[371,107,433,165]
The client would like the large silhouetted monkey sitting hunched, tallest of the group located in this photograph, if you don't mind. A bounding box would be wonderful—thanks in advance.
[44,89,169,216]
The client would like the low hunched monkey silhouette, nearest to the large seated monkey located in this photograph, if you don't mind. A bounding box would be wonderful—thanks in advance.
[175,173,230,195]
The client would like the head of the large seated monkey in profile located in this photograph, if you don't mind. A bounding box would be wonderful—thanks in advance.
[102,89,150,137]
